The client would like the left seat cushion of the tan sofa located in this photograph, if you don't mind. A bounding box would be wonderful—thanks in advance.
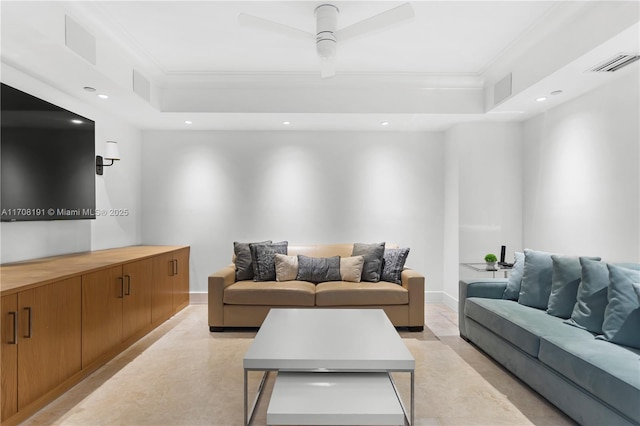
[223,281,316,306]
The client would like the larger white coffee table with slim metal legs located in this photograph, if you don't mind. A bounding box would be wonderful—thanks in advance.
[243,309,415,425]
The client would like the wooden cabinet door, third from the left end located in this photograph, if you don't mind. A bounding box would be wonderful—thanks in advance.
[82,266,125,367]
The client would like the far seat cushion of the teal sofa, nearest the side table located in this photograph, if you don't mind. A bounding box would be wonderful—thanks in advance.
[464,297,593,357]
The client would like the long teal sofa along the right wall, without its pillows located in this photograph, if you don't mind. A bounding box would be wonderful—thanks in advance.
[459,251,640,425]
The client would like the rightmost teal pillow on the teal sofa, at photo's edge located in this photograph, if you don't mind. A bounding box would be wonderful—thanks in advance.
[598,265,640,349]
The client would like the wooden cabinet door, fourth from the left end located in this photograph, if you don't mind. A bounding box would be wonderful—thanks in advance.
[122,259,153,340]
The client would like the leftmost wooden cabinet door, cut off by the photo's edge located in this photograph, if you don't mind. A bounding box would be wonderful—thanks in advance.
[0,294,18,420]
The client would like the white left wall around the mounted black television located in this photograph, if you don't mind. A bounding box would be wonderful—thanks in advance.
[0,63,141,263]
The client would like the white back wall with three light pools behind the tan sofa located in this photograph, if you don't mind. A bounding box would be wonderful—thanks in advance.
[142,131,443,292]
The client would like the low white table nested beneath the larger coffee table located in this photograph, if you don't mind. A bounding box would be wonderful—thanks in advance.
[267,371,405,425]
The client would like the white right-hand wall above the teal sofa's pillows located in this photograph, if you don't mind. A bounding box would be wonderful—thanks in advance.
[523,73,640,262]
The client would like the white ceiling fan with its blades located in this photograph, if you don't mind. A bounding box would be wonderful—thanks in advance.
[238,3,415,78]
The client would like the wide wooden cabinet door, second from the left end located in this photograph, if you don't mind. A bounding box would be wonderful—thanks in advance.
[18,277,82,410]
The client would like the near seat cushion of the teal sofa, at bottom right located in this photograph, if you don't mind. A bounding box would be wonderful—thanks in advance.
[538,336,640,423]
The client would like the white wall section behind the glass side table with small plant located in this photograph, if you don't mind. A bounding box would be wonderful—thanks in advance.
[443,123,523,308]
